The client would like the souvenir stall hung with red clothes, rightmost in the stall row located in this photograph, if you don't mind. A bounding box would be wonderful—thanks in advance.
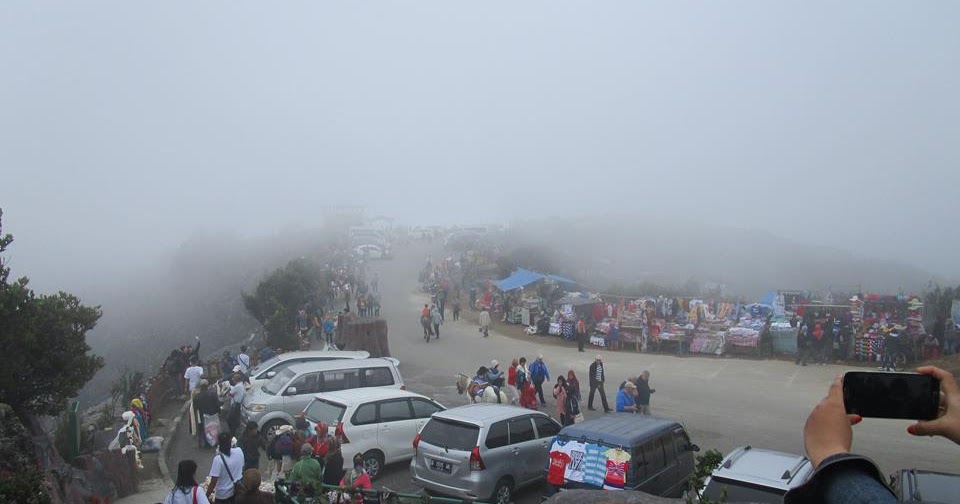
[851,293,926,362]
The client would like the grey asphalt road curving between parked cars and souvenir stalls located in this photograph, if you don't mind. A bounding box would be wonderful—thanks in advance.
[168,245,960,503]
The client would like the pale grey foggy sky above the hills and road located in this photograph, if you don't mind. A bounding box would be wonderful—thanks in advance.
[0,0,960,290]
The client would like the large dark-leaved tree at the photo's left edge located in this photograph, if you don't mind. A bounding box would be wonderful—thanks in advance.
[0,211,103,416]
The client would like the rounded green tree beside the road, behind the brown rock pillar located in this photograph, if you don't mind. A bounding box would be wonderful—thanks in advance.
[243,259,329,349]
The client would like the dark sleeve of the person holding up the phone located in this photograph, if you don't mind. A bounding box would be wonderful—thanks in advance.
[783,453,898,504]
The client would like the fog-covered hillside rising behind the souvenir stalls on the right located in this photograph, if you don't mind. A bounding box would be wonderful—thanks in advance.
[507,215,934,299]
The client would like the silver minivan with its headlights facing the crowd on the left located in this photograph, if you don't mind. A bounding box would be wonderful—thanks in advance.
[243,358,406,436]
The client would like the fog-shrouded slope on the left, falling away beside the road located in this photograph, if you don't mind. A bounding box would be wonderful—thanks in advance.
[81,226,342,401]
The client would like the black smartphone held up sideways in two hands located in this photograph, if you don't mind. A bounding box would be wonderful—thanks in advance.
[843,371,940,420]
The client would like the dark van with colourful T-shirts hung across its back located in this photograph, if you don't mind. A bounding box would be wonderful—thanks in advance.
[547,413,700,497]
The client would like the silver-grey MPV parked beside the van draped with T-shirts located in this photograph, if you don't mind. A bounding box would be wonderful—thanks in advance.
[410,404,560,503]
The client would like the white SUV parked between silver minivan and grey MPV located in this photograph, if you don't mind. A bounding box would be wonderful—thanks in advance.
[304,388,446,478]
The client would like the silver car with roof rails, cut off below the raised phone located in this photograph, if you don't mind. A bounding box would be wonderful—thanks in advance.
[703,445,813,502]
